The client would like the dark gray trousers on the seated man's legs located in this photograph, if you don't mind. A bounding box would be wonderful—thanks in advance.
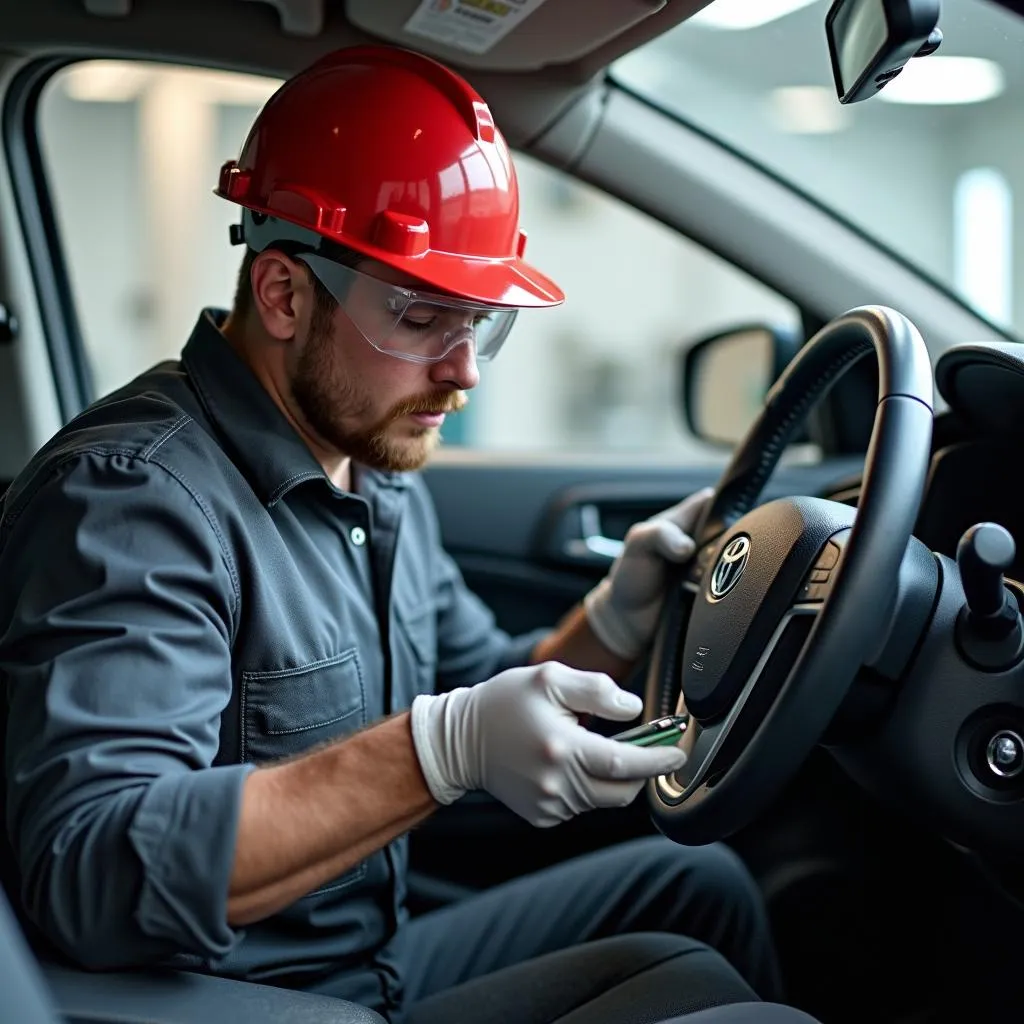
[402,837,782,1024]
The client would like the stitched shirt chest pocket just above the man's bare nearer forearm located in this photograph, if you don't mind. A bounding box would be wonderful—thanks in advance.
[242,647,367,764]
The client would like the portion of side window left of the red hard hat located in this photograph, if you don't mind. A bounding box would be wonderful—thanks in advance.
[39,60,280,394]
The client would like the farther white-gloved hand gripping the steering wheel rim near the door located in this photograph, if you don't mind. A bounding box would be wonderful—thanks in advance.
[584,487,715,660]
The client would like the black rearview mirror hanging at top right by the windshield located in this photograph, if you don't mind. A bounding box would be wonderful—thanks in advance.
[825,0,942,103]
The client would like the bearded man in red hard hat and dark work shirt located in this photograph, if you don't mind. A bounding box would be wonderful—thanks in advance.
[0,41,776,1024]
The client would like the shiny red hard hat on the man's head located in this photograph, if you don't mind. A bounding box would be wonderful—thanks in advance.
[215,46,565,306]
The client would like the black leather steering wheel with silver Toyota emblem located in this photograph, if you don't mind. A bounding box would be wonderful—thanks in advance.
[644,306,933,844]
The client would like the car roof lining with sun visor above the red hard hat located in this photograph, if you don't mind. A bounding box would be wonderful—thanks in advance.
[0,0,710,146]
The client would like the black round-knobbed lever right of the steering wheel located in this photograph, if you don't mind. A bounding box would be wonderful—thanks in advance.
[956,522,1024,672]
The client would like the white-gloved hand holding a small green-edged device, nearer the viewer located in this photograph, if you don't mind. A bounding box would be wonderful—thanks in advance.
[412,662,686,827]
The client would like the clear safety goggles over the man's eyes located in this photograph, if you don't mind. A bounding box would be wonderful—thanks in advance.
[296,253,519,362]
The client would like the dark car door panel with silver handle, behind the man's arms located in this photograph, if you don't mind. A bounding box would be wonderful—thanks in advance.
[411,453,861,909]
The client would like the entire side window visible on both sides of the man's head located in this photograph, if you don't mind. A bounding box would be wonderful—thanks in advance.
[40,60,800,460]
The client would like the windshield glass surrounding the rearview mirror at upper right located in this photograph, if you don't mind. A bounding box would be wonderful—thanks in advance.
[613,0,1024,335]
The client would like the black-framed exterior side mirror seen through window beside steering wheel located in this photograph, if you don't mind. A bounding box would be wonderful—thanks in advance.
[681,324,803,447]
